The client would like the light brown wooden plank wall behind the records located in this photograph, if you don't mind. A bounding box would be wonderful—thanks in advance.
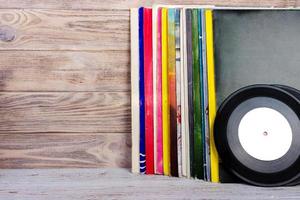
[0,0,300,168]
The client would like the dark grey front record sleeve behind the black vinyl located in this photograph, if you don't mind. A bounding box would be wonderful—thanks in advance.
[214,10,300,105]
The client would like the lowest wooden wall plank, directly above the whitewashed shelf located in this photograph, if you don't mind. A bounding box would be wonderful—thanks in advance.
[0,133,131,168]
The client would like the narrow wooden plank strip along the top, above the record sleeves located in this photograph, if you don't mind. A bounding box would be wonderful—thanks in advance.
[0,0,292,10]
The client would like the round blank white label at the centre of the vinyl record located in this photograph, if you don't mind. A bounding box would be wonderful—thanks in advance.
[238,107,293,161]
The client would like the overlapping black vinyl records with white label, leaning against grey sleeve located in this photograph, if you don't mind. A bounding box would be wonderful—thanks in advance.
[214,85,300,186]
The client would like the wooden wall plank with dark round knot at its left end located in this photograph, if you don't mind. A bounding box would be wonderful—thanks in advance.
[0,9,130,51]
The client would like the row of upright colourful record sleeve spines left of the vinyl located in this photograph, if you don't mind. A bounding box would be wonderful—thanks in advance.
[131,6,219,182]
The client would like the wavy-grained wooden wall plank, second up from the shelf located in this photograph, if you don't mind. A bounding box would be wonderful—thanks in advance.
[0,92,131,133]
